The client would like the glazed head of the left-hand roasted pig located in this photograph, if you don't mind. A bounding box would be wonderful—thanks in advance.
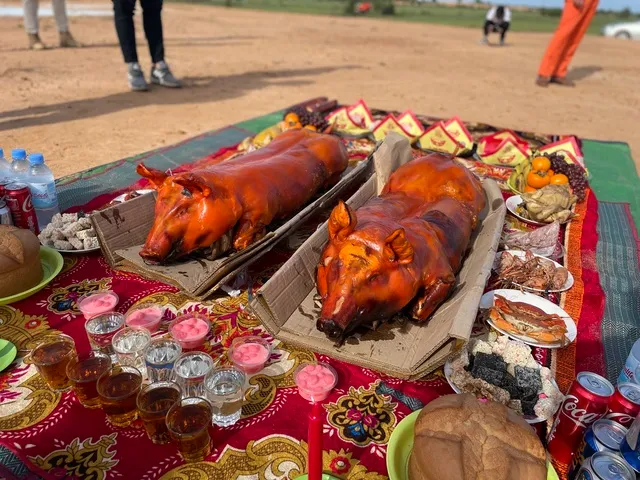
[137,163,241,262]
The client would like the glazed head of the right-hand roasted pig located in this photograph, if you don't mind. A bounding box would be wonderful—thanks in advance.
[317,202,418,338]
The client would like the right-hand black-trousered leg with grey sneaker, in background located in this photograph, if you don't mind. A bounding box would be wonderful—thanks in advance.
[140,0,181,88]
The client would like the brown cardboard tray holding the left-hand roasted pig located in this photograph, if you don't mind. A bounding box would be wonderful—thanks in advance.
[91,148,372,299]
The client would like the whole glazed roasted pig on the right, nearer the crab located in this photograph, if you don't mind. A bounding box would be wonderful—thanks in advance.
[317,154,485,338]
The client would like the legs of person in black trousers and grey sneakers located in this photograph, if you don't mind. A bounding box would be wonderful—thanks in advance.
[113,0,181,91]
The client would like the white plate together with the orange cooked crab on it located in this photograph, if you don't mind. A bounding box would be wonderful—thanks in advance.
[480,289,578,348]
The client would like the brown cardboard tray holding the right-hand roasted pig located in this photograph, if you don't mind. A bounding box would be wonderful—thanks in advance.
[250,135,506,379]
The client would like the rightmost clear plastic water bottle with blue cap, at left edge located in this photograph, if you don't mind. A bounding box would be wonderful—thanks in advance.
[25,153,60,231]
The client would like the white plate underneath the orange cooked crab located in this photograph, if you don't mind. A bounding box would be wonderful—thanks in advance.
[480,289,578,348]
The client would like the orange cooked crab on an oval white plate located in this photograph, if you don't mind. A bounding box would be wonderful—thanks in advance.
[489,295,567,343]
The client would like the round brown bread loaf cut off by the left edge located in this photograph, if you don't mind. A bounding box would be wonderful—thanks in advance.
[0,225,42,297]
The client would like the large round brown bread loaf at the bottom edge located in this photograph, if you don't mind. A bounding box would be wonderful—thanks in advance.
[409,394,547,480]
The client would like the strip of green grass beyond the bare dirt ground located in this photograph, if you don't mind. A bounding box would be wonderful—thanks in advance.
[169,0,638,35]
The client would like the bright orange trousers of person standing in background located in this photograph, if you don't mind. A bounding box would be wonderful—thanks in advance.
[538,0,598,78]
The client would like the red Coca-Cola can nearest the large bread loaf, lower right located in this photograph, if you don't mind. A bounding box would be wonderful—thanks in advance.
[547,372,615,465]
